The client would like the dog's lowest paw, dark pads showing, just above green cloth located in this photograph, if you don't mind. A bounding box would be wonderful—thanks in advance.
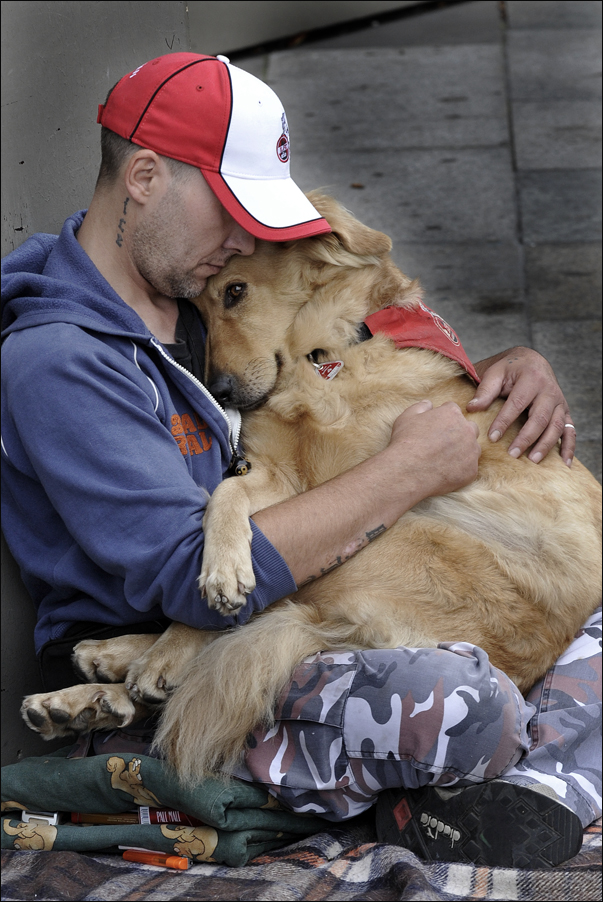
[21,683,140,739]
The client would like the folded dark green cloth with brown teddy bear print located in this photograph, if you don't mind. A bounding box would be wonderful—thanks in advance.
[2,749,325,867]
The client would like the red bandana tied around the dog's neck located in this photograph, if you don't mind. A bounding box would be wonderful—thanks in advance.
[364,301,480,384]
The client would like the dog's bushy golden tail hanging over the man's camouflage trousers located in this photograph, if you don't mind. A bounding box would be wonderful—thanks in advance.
[153,602,357,785]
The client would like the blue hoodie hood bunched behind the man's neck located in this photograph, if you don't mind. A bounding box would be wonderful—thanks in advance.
[2,210,151,341]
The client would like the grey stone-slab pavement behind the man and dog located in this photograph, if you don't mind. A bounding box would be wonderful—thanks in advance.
[238,0,601,479]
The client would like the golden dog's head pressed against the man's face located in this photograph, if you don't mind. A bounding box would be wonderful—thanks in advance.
[195,198,415,410]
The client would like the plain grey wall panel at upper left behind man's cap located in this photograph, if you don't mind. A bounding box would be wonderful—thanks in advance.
[2,0,189,256]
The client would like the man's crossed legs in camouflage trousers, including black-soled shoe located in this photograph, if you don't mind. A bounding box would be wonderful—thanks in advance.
[237,618,600,867]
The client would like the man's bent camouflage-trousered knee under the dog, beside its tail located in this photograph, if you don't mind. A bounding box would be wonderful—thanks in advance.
[234,643,534,821]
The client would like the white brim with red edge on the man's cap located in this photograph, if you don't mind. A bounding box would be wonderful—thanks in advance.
[201,169,331,241]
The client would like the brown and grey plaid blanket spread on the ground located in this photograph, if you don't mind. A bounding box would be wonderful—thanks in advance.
[2,813,601,902]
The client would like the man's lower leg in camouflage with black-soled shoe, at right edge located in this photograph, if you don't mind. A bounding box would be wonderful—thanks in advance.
[377,608,601,867]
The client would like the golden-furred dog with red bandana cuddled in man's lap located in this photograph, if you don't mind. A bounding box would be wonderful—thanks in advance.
[24,193,601,781]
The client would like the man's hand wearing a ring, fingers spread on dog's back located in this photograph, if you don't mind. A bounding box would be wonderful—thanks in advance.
[467,348,576,467]
